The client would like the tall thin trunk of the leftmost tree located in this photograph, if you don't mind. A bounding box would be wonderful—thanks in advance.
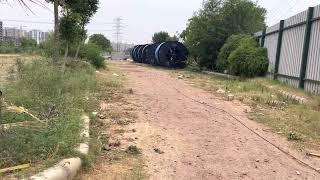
[53,0,59,64]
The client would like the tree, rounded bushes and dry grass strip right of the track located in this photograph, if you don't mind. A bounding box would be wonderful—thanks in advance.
[179,0,320,150]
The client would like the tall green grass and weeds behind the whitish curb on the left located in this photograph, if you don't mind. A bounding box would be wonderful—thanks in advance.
[0,59,96,175]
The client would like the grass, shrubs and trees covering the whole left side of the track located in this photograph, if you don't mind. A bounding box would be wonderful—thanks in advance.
[0,0,115,179]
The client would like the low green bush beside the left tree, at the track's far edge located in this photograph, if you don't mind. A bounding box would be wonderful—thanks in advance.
[79,43,105,68]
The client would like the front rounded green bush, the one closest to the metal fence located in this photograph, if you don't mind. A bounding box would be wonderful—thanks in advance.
[228,43,269,77]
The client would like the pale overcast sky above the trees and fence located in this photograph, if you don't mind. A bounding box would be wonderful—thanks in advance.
[0,0,320,43]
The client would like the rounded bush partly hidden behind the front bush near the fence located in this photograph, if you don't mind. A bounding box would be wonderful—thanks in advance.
[216,34,257,72]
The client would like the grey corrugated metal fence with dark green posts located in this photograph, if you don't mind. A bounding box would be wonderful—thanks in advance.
[255,5,320,94]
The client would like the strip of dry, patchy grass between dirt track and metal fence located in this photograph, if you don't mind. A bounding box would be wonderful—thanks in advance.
[174,70,320,147]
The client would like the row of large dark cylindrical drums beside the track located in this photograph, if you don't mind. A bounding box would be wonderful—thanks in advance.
[130,41,189,68]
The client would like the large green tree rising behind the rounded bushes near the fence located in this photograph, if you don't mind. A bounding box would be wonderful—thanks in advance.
[181,0,266,69]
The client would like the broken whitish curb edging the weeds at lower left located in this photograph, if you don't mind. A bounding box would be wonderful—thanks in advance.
[29,116,90,180]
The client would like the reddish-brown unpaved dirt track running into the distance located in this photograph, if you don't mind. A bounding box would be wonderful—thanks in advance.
[115,62,320,179]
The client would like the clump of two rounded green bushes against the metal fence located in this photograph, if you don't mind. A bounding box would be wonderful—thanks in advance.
[217,35,269,78]
